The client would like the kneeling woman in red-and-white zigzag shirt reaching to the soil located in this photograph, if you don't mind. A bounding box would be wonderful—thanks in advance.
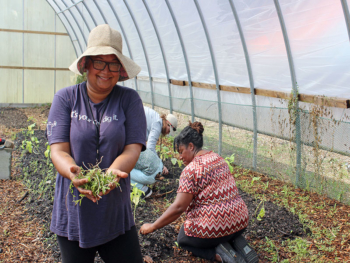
[140,122,258,262]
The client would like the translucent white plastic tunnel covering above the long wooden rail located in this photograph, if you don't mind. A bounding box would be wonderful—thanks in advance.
[47,0,350,104]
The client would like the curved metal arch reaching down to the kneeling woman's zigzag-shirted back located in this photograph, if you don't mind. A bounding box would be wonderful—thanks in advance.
[194,0,222,154]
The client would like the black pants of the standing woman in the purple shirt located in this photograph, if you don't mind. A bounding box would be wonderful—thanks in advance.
[57,226,143,263]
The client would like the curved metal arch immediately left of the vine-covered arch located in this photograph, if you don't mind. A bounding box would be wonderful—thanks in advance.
[229,0,258,170]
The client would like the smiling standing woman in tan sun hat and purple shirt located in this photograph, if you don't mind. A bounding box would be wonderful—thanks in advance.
[47,25,146,263]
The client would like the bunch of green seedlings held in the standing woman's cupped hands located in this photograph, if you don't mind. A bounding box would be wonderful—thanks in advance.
[69,163,119,205]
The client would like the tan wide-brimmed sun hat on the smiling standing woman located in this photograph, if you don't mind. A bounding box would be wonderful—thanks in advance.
[69,24,141,81]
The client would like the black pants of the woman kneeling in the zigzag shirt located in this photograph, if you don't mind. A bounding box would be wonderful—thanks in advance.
[177,225,245,261]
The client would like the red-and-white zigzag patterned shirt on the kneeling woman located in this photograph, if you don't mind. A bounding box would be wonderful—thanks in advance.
[177,152,249,238]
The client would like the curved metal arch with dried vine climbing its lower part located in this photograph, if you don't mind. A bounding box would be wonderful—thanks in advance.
[274,0,301,187]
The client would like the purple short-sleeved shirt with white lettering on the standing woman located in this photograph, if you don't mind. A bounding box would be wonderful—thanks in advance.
[47,82,146,248]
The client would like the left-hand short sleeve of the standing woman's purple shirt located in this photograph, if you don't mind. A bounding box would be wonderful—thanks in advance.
[46,90,71,145]
